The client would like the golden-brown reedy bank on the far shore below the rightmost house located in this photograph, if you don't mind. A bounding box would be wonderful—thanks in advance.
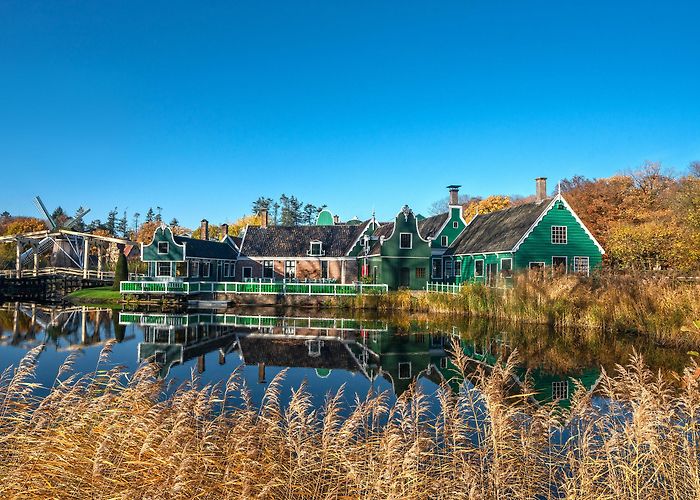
[346,276,700,349]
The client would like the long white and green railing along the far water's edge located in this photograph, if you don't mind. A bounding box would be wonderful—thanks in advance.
[119,281,388,295]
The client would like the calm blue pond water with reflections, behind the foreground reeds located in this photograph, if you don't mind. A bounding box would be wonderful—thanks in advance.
[0,303,689,410]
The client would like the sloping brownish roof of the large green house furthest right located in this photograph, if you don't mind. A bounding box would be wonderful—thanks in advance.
[446,199,551,255]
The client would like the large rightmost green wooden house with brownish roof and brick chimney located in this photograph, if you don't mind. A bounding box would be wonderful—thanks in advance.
[443,178,605,286]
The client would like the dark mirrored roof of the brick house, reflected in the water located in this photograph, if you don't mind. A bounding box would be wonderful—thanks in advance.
[238,336,358,371]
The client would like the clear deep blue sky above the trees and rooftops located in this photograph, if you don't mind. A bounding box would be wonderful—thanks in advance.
[0,0,700,226]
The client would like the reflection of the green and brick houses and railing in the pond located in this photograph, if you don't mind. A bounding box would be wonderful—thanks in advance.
[120,312,600,405]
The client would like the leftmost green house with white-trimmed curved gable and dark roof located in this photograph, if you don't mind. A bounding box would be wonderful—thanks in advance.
[141,220,238,281]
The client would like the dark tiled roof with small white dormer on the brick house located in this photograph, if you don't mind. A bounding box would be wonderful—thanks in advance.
[241,222,367,257]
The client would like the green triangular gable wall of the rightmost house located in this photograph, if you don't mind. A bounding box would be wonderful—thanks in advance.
[514,201,602,273]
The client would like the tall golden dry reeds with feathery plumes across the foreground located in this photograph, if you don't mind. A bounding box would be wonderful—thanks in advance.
[0,345,700,499]
